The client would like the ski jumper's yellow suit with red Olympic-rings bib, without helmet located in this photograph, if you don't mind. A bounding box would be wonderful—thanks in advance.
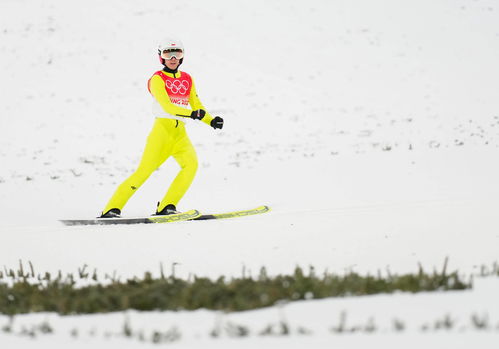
[103,71,213,213]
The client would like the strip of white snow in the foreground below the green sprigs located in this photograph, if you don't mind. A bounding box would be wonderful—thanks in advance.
[0,278,499,348]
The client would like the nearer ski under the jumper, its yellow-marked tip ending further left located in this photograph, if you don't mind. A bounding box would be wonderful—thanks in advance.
[61,210,201,225]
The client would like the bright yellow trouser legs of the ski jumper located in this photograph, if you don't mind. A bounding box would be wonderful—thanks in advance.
[103,118,198,213]
